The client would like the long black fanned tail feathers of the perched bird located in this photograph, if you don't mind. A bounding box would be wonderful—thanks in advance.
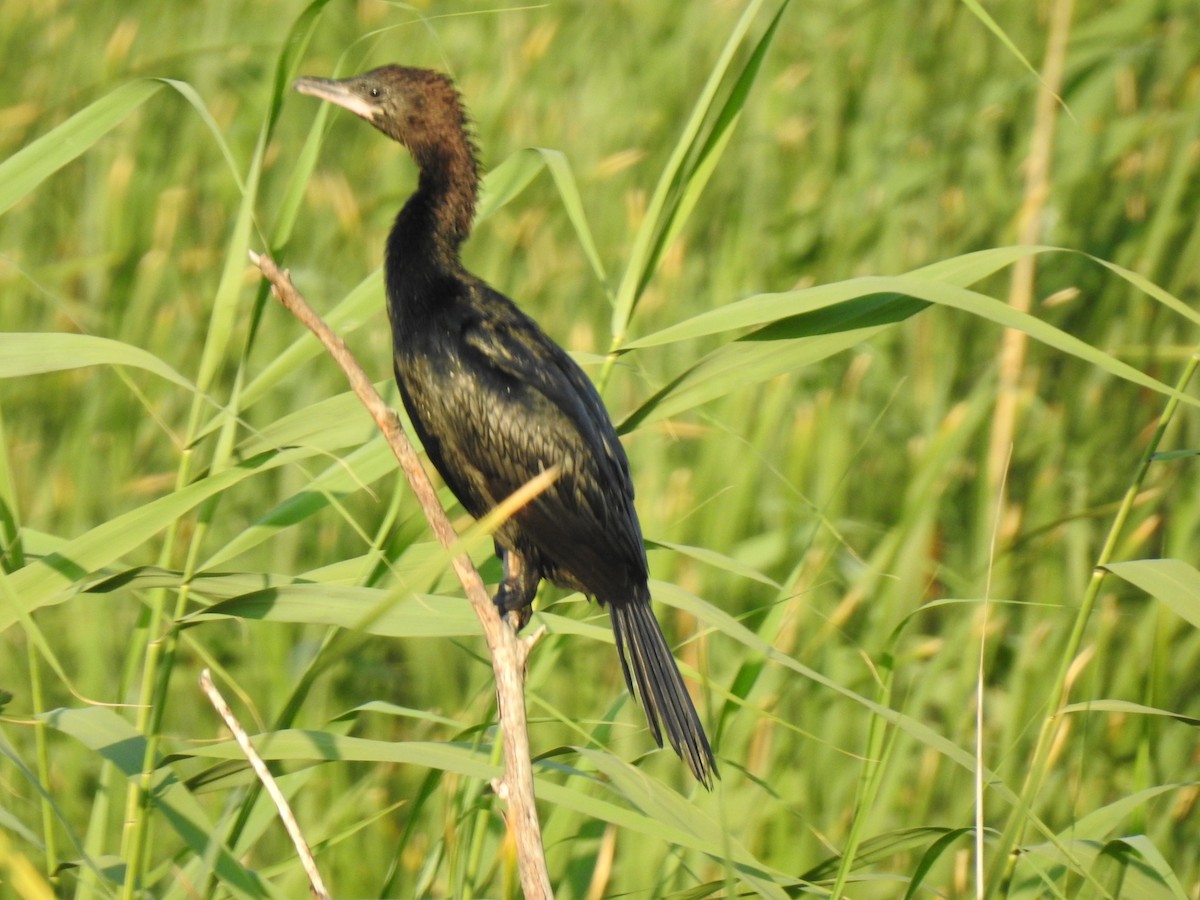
[608,598,719,790]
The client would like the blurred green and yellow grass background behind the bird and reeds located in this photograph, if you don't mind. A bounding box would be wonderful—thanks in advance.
[0,0,1200,898]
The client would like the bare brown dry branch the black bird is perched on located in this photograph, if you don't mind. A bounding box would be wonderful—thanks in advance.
[250,251,553,900]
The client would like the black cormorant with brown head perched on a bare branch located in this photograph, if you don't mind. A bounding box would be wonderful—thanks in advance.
[295,66,716,788]
